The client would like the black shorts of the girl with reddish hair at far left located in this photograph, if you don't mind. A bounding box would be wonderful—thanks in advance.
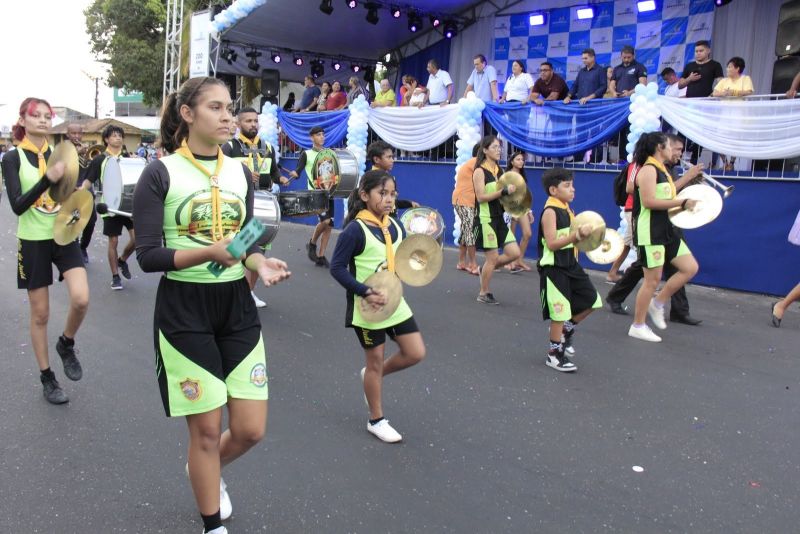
[17,239,85,291]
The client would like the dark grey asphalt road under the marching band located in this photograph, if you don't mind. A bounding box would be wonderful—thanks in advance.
[0,206,800,533]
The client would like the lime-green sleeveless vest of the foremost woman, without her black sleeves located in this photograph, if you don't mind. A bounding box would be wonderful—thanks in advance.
[159,154,249,284]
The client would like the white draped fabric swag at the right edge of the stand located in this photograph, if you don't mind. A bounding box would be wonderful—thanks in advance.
[658,96,800,159]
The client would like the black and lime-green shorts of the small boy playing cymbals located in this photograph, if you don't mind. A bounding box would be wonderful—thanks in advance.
[539,264,603,322]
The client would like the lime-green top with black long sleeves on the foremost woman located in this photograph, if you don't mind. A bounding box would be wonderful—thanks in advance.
[133,154,260,284]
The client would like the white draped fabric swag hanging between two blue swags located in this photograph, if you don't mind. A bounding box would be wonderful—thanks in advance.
[369,104,458,152]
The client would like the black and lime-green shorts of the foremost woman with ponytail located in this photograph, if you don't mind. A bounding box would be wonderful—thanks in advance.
[153,277,268,417]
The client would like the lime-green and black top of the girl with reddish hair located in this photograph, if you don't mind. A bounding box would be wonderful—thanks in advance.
[2,148,61,241]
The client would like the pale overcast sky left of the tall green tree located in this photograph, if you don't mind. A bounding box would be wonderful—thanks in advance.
[0,0,114,117]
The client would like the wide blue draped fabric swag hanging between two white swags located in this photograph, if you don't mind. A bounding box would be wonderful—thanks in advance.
[483,98,630,157]
